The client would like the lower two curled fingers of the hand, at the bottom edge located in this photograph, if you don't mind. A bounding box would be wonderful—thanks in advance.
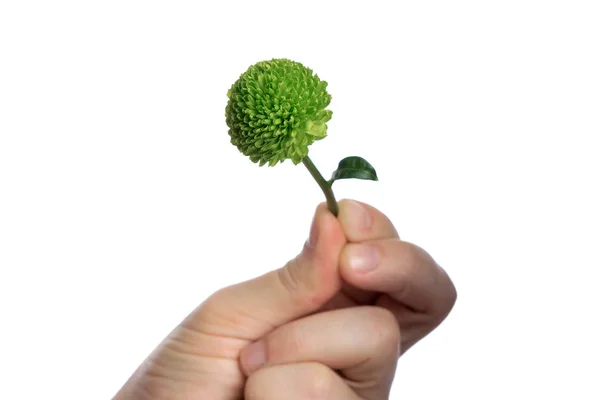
[241,306,400,400]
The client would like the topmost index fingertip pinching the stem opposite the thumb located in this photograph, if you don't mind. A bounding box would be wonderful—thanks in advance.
[338,200,399,242]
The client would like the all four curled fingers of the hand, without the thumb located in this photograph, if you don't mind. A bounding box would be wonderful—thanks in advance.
[241,201,456,400]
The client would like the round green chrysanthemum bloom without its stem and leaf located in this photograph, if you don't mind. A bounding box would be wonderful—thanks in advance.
[225,59,332,166]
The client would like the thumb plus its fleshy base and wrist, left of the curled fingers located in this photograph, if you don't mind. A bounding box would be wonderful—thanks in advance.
[115,205,346,400]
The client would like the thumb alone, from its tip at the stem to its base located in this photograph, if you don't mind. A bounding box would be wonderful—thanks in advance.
[184,204,346,341]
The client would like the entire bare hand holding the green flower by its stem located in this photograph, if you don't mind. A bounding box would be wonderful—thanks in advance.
[114,200,456,400]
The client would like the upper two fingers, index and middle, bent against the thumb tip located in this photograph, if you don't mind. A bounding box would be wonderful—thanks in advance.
[325,200,457,353]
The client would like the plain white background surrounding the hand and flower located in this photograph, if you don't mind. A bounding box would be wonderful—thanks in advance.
[0,0,600,400]
